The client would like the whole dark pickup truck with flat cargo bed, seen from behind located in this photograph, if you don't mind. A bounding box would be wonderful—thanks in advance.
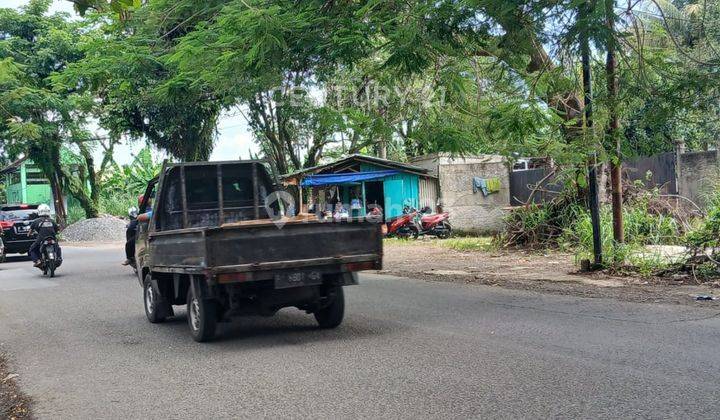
[135,161,382,341]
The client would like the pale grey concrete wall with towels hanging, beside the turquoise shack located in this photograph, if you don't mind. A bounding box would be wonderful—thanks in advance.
[412,155,510,233]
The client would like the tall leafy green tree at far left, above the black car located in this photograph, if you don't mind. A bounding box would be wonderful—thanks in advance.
[0,0,88,224]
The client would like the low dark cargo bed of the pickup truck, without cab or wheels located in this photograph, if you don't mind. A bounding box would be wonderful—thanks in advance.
[150,219,382,273]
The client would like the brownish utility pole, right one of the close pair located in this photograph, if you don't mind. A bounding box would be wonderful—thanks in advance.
[605,0,625,244]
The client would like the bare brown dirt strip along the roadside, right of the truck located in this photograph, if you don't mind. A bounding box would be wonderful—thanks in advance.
[380,239,720,308]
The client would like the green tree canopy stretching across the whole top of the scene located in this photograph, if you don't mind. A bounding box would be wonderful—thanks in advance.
[0,0,720,217]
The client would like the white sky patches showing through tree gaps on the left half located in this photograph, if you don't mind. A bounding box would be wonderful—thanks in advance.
[0,0,258,164]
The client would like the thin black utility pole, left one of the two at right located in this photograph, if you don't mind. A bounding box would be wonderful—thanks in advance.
[578,0,602,267]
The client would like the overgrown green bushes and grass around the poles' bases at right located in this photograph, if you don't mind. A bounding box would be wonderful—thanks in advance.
[496,186,696,276]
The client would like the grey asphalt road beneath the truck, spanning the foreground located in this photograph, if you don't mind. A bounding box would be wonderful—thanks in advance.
[0,247,720,419]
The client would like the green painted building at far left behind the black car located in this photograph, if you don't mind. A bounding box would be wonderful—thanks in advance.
[0,158,53,206]
